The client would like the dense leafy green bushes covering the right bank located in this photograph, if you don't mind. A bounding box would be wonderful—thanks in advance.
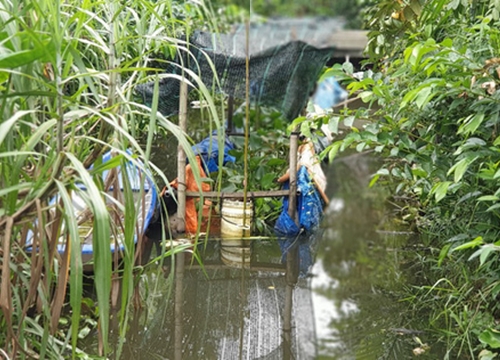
[296,0,500,357]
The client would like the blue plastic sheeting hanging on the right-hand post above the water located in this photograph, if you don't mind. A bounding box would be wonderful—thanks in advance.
[274,166,323,276]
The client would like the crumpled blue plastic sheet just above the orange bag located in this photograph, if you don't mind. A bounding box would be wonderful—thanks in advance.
[192,132,236,174]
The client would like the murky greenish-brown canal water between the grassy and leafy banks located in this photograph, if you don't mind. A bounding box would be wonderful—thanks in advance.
[83,151,443,360]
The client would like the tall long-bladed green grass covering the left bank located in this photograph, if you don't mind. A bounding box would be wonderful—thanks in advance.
[0,0,222,358]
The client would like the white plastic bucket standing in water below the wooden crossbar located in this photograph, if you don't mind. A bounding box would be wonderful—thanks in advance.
[220,199,253,242]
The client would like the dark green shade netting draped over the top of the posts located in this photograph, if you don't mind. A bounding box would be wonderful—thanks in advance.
[137,19,341,120]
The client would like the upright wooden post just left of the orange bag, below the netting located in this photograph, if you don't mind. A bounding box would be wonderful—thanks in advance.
[177,81,188,233]
